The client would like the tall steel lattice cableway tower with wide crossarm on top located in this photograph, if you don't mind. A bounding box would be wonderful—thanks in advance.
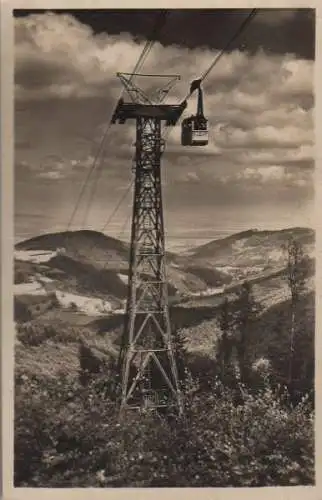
[112,73,186,414]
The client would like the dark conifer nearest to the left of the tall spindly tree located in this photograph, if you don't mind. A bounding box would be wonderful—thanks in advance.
[233,281,261,383]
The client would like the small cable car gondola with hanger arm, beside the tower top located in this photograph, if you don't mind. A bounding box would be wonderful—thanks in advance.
[181,79,208,146]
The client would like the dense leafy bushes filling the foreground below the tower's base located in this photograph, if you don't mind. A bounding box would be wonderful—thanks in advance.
[15,373,314,487]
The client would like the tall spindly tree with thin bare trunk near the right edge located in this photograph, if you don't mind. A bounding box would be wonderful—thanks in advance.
[282,237,308,384]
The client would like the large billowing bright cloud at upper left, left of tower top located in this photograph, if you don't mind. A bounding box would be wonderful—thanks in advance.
[15,13,142,99]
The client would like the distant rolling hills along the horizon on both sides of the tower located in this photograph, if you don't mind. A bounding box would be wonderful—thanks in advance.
[15,228,315,304]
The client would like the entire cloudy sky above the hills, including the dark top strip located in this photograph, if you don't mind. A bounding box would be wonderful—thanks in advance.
[15,9,315,248]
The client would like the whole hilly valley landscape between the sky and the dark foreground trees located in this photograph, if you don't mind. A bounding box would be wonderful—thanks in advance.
[14,228,314,386]
